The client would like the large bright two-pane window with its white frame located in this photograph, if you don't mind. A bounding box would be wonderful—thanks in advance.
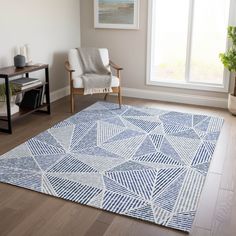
[147,0,233,91]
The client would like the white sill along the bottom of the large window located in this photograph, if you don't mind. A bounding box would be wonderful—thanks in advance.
[147,80,229,93]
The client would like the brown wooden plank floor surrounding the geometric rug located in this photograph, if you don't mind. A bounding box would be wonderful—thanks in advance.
[0,96,236,236]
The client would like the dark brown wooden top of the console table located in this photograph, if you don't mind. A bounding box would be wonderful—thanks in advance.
[0,63,48,77]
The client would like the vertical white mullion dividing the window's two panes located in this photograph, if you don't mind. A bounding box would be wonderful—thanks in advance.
[185,0,195,83]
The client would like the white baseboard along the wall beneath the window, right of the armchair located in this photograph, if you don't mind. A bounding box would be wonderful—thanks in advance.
[122,88,227,108]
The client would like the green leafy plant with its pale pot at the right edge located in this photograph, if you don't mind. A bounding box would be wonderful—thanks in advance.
[220,26,236,115]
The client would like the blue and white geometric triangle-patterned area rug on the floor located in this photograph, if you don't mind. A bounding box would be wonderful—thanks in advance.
[0,102,223,231]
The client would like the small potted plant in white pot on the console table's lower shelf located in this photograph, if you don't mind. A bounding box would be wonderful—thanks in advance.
[0,83,19,116]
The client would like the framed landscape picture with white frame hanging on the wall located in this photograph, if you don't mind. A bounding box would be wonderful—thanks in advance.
[94,0,140,30]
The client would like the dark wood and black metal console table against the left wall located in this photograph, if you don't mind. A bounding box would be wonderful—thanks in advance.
[0,64,50,134]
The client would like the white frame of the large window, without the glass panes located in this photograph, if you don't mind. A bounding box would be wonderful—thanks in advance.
[146,0,236,93]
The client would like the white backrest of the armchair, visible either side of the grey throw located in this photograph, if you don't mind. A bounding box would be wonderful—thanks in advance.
[68,48,110,79]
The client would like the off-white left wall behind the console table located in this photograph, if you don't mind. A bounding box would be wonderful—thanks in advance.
[0,0,80,91]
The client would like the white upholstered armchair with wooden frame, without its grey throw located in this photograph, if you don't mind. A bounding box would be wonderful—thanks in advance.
[65,48,123,113]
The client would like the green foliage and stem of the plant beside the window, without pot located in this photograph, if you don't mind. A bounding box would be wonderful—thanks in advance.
[220,26,236,96]
